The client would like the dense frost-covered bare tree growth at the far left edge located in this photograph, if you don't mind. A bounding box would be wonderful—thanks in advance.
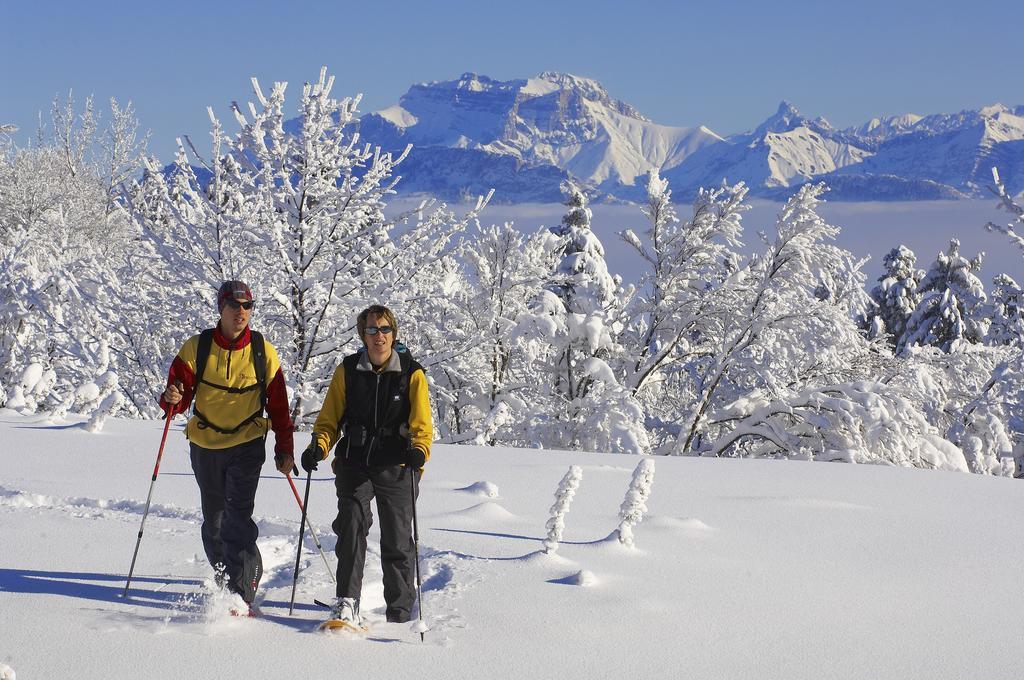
[0,97,154,412]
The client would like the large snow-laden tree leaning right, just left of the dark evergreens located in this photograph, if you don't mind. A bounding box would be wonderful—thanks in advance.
[667,184,879,455]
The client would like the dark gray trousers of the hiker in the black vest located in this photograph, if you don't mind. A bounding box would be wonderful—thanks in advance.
[334,464,420,623]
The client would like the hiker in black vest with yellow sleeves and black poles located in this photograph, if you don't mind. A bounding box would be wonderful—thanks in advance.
[302,305,433,625]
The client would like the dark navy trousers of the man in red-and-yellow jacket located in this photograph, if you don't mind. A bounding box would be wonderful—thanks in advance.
[190,437,266,602]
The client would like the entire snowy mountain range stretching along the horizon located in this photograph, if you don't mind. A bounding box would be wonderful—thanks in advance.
[323,72,1024,203]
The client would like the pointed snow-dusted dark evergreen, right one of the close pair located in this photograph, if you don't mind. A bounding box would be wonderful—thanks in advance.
[897,239,988,352]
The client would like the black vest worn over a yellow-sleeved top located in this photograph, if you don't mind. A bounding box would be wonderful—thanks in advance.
[335,348,423,466]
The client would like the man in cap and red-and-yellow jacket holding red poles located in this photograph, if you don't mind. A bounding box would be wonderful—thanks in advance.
[160,281,294,615]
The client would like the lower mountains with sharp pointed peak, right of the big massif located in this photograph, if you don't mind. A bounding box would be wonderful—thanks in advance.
[665,101,1024,201]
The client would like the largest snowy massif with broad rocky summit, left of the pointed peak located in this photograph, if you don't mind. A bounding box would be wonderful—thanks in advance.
[360,72,722,201]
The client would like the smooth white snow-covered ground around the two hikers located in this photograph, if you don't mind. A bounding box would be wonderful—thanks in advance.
[0,411,1024,680]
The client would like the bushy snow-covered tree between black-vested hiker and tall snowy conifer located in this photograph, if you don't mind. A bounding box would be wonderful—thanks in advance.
[417,223,559,447]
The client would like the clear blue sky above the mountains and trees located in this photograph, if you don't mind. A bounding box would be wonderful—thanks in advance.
[0,0,1024,160]
